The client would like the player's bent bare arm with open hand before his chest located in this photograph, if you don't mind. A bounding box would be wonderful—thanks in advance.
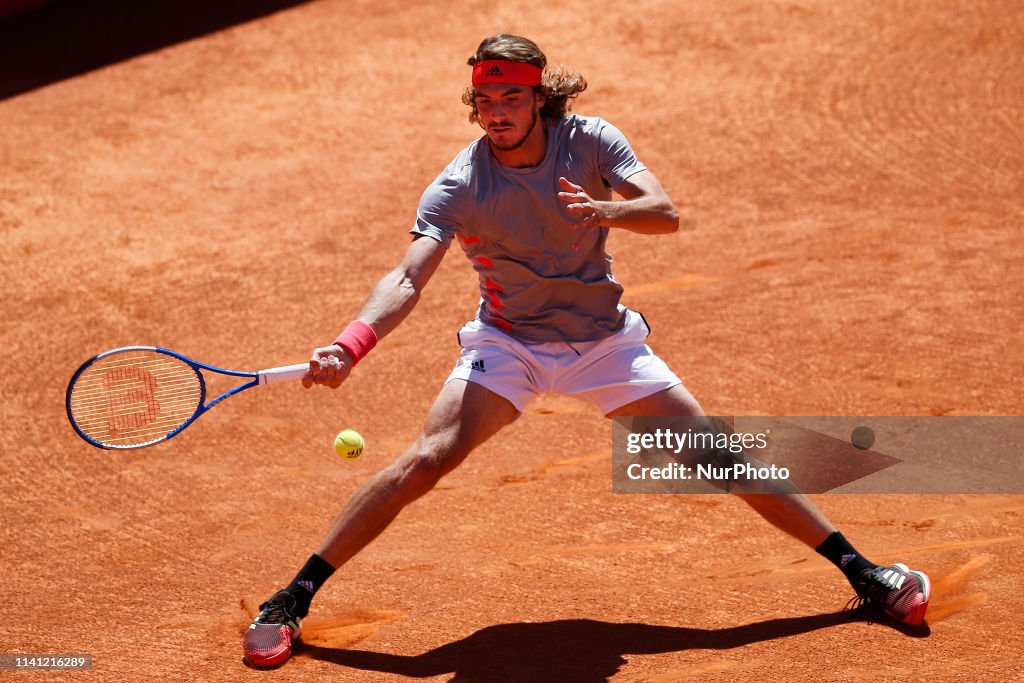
[558,171,679,246]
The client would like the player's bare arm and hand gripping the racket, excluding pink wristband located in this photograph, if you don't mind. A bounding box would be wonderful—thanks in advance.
[302,237,447,389]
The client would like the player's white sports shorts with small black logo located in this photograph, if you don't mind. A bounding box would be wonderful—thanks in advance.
[444,310,682,415]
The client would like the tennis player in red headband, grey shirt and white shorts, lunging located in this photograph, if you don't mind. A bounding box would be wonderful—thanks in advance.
[244,34,930,667]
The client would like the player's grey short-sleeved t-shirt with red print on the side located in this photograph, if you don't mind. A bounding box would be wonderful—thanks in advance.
[411,115,646,343]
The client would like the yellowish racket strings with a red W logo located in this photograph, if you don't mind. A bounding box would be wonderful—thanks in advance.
[71,350,204,446]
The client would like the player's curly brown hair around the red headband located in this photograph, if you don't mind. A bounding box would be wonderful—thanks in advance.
[462,33,587,123]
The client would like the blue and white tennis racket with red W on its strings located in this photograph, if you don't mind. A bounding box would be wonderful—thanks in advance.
[67,346,309,449]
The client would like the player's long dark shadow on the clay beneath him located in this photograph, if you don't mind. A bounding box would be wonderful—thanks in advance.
[296,611,930,683]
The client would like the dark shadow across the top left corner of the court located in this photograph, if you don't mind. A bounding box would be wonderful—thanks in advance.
[0,0,308,100]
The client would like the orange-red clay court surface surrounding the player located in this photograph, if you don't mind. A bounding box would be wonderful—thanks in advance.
[0,0,1024,683]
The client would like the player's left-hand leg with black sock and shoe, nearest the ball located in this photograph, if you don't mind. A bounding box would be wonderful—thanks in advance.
[243,380,519,667]
